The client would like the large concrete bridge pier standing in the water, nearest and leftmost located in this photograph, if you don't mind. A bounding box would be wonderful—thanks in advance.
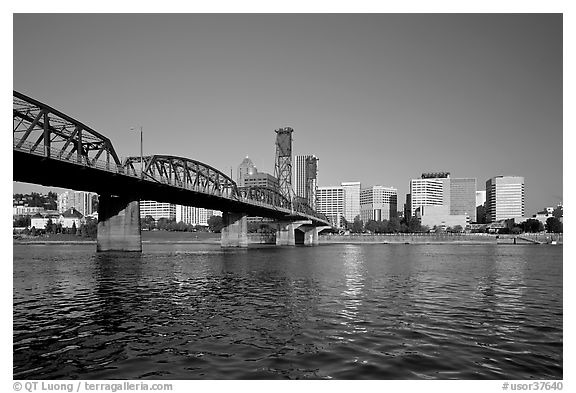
[96,195,142,252]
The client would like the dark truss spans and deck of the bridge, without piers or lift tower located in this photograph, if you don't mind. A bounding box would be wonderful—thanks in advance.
[13,91,331,226]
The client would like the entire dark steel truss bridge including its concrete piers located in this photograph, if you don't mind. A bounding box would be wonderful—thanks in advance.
[13,91,332,251]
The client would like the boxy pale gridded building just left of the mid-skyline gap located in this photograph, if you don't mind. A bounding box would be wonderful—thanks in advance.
[360,186,398,223]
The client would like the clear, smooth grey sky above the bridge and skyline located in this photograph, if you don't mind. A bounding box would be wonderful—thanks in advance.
[13,14,563,215]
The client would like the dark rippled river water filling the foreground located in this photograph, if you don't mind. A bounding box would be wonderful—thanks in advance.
[13,244,563,379]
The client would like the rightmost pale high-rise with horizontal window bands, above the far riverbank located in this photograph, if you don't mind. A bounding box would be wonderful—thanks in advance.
[486,176,525,223]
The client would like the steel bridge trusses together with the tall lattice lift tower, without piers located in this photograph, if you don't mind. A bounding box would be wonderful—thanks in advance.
[13,91,328,223]
